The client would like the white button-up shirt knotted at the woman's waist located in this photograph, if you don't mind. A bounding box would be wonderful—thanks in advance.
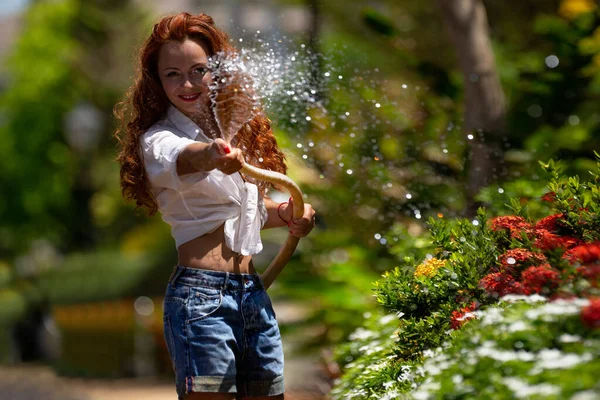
[140,106,267,255]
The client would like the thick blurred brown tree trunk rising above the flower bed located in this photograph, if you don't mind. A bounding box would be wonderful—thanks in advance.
[438,0,506,216]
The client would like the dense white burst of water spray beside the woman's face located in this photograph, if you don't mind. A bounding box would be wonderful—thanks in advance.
[207,38,326,142]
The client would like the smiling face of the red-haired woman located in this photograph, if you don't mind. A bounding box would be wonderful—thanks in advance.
[158,39,210,116]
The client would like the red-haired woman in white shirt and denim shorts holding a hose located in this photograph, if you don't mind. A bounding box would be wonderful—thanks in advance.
[115,13,315,400]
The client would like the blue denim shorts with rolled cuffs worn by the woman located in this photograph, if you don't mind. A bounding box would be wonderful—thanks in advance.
[163,266,283,400]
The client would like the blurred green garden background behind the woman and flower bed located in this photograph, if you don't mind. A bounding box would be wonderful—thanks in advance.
[0,0,600,394]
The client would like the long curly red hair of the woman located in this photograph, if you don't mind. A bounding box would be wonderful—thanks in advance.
[114,13,287,215]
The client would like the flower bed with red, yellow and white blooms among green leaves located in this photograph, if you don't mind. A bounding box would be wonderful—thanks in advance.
[331,158,600,399]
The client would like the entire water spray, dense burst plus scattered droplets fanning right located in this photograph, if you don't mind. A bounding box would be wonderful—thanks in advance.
[199,35,476,245]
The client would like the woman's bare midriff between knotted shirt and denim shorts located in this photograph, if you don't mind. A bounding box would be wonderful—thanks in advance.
[177,224,256,274]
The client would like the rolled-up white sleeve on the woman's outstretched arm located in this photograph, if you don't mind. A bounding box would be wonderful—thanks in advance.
[140,130,208,190]
